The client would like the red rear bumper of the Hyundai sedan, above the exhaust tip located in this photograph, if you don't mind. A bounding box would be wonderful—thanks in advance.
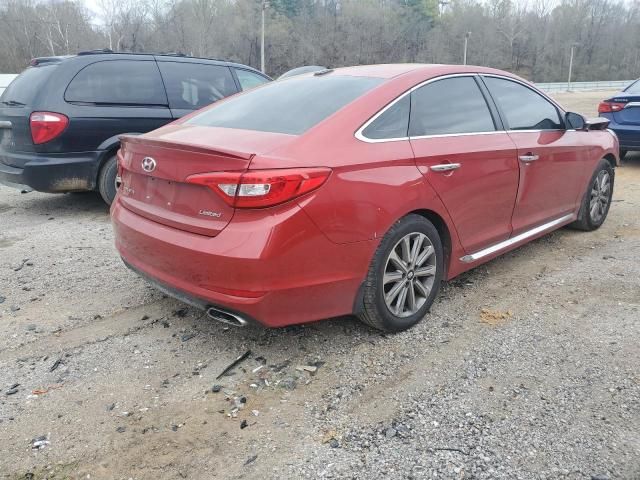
[111,198,376,327]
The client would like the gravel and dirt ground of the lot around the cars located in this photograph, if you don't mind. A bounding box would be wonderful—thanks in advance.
[0,92,640,480]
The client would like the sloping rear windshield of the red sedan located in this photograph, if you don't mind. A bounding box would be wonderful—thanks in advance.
[185,74,383,135]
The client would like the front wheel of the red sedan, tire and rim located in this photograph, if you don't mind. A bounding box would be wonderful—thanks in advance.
[571,158,615,232]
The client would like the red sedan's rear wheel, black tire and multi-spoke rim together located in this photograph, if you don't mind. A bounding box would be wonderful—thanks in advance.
[358,214,444,332]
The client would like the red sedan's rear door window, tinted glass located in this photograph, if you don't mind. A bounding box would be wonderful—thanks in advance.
[409,77,495,137]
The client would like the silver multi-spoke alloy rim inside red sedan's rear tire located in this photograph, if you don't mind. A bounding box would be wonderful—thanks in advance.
[382,232,437,317]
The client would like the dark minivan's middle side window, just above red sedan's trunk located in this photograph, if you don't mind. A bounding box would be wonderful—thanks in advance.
[158,62,237,110]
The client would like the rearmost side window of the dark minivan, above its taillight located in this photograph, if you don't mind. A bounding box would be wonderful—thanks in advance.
[64,60,167,106]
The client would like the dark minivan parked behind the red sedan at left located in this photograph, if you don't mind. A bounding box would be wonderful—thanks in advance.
[0,51,271,204]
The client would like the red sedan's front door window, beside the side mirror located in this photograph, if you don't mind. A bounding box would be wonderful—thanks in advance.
[484,77,562,130]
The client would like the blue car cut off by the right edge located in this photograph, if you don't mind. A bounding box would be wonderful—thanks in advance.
[598,79,640,159]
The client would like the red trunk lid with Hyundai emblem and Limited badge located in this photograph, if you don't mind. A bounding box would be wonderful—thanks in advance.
[119,124,292,237]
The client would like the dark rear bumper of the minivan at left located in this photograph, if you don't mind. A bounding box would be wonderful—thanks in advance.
[0,150,103,193]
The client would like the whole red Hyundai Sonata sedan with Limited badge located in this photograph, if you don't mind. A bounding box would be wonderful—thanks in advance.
[112,65,619,331]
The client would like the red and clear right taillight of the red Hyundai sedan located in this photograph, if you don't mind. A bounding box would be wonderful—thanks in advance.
[187,168,331,208]
